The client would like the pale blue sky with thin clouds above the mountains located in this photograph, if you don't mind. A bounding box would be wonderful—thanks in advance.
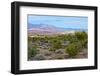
[28,15,88,29]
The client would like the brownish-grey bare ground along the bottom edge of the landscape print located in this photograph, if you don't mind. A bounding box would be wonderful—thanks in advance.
[30,48,88,60]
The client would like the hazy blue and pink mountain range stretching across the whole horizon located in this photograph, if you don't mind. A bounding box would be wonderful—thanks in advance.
[28,23,87,35]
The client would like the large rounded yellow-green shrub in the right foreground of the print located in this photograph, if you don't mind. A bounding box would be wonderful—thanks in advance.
[65,43,80,57]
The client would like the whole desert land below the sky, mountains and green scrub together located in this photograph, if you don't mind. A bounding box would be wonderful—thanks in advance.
[28,24,88,61]
